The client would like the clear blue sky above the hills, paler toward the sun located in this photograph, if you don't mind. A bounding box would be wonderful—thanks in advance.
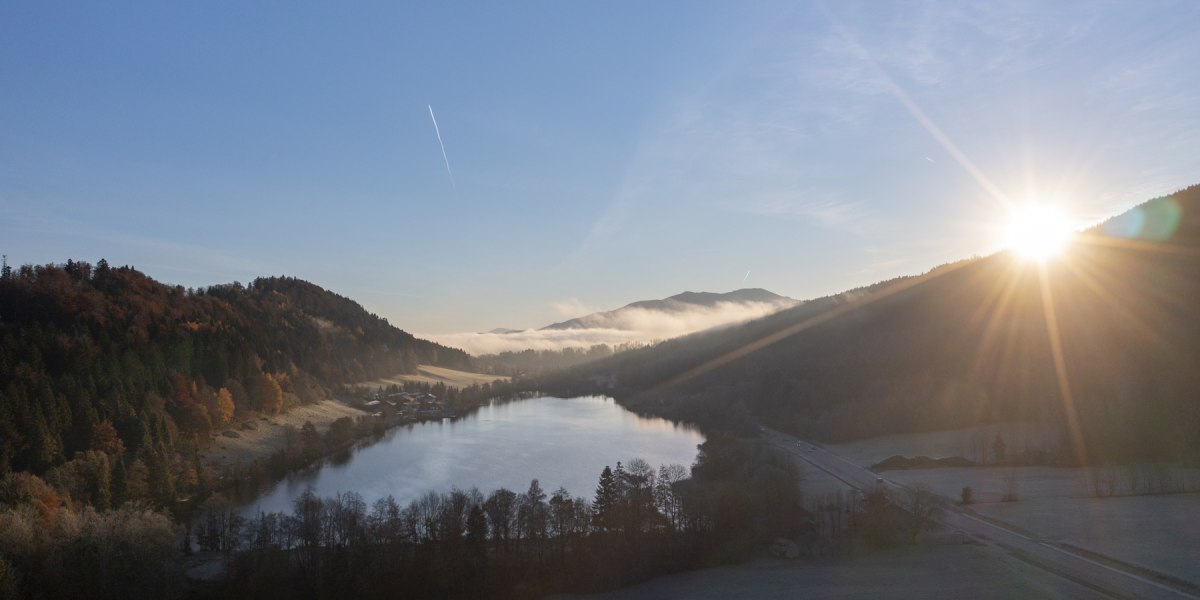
[0,1,1200,332]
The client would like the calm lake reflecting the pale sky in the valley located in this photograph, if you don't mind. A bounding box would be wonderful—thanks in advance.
[241,396,704,515]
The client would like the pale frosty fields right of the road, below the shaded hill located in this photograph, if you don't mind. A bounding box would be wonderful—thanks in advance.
[827,424,1200,586]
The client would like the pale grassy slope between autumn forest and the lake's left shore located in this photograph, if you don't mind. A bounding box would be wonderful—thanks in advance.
[200,400,366,469]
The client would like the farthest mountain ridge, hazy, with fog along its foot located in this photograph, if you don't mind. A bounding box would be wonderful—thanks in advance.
[541,288,800,331]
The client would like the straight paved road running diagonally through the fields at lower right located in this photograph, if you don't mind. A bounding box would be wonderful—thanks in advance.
[763,430,1200,600]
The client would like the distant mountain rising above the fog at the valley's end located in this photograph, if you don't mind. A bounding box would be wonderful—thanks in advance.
[541,288,798,331]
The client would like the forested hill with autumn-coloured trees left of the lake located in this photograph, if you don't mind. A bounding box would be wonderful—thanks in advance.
[0,260,469,475]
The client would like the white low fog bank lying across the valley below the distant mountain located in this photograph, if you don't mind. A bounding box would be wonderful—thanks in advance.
[416,302,792,356]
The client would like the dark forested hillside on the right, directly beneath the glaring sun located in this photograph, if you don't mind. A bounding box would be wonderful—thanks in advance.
[553,186,1200,460]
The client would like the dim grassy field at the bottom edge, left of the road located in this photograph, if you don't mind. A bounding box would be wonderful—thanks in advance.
[571,544,1096,600]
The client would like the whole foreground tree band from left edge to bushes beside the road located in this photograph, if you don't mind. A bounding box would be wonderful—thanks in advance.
[0,434,955,599]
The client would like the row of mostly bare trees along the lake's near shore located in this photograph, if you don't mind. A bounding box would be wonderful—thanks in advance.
[192,437,806,598]
